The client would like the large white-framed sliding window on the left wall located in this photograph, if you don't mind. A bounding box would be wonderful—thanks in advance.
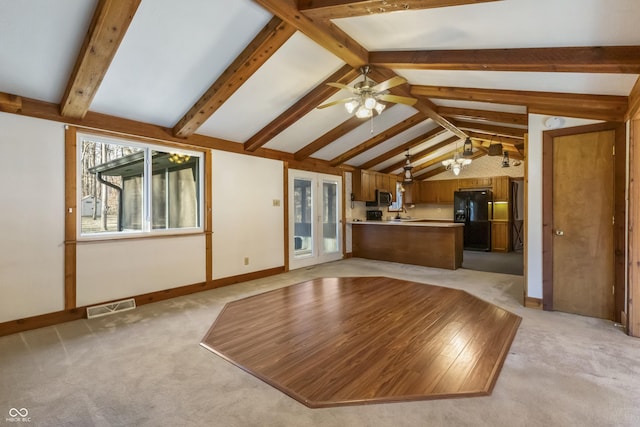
[77,134,203,236]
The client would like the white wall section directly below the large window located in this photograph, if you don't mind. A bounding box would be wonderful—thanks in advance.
[76,235,206,306]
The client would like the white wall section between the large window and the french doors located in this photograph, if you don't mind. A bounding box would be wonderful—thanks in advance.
[212,150,284,279]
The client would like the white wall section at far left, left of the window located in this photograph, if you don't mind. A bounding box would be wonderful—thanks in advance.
[0,113,64,322]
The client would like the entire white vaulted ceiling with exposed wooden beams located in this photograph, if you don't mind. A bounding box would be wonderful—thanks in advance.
[0,0,640,179]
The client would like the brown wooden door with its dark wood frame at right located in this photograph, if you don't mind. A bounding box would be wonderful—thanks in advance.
[543,123,624,320]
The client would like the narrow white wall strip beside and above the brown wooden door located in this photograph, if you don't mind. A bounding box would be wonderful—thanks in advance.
[526,114,599,298]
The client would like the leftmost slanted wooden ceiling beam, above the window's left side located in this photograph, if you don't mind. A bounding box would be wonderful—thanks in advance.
[60,0,141,119]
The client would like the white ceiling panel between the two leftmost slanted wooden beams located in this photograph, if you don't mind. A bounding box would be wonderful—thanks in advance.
[91,0,271,127]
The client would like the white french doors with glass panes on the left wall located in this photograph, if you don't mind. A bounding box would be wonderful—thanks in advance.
[289,169,342,270]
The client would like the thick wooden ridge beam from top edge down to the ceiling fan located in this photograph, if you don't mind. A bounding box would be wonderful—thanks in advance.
[254,0,369,69]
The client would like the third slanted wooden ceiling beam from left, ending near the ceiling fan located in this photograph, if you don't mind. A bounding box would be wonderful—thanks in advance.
[244,65,360,151]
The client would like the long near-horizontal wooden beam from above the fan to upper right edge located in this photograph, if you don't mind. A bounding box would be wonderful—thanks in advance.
[369,46,640,74]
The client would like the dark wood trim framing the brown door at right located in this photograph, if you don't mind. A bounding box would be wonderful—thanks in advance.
[542,122,626,322]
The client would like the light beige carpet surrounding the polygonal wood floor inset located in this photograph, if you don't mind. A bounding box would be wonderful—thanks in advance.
[0,259,640,427]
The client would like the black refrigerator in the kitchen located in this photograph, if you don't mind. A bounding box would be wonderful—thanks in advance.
[453,190,493,251]
